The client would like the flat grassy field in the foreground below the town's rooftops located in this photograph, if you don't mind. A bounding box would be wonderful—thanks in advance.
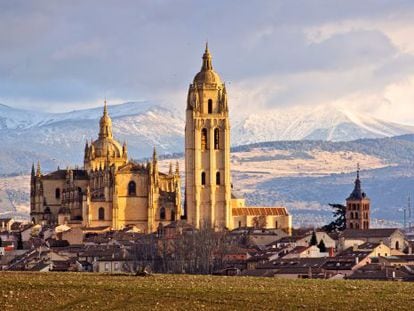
[0,272,414,311]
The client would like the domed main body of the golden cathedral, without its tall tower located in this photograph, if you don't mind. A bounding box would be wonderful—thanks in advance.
[30,101,182,232]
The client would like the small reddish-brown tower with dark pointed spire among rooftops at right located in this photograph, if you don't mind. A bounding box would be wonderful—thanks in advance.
[345,165,371,229]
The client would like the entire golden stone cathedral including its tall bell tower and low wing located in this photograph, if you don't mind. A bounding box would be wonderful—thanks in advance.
[30,45,292,233]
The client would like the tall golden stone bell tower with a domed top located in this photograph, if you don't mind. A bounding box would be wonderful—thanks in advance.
[185,45,232,229]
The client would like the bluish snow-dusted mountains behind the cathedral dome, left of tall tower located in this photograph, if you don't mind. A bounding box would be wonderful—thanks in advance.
[0,102,184,174]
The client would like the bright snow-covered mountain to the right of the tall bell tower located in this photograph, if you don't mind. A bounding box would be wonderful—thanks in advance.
[232,106,414,145]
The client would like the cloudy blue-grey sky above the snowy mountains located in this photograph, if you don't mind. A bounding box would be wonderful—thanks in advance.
[0,0,414,124]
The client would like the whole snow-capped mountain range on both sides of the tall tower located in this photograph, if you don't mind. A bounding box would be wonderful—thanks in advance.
[0,102,414,174]
